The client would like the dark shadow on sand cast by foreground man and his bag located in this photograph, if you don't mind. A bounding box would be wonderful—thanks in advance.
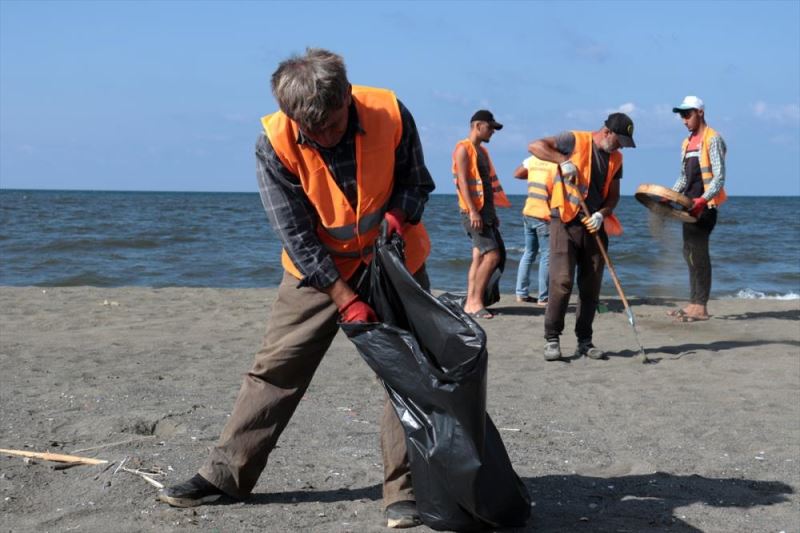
[239,472,794,532]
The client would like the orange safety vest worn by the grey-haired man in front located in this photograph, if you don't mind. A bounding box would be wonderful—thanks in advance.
[261,85,431,280]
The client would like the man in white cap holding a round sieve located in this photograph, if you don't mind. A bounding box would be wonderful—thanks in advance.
[670,96,727,322]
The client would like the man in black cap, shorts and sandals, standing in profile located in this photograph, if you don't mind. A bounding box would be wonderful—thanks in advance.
[452,109,511,318]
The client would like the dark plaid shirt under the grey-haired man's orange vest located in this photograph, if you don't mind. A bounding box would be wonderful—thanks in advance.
[256,101,435,289]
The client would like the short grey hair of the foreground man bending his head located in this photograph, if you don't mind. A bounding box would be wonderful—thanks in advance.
[272,48,350,131]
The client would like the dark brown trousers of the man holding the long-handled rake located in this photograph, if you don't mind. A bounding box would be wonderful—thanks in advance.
[544,218,608,342]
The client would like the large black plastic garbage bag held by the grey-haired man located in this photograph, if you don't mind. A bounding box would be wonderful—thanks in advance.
[342,237,530,531]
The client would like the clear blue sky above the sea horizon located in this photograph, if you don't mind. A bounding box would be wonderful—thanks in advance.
[0,0,800,195]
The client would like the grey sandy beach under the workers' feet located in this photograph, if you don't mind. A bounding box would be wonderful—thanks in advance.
[0,287,800,533]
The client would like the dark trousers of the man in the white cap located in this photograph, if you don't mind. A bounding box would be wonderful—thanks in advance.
[683,208,717,305]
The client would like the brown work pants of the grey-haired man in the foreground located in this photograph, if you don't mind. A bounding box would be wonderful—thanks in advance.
[199,266,429,506]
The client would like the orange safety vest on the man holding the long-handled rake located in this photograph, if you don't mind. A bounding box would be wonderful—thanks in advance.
[550,131,622,235]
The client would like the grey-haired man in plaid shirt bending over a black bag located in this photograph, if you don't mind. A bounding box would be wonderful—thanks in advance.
[160,49,434,527]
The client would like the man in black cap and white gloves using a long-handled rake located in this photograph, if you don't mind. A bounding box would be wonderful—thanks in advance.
[528,113,636,361]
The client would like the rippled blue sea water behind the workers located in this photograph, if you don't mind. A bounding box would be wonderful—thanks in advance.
[0,190,800,299]
